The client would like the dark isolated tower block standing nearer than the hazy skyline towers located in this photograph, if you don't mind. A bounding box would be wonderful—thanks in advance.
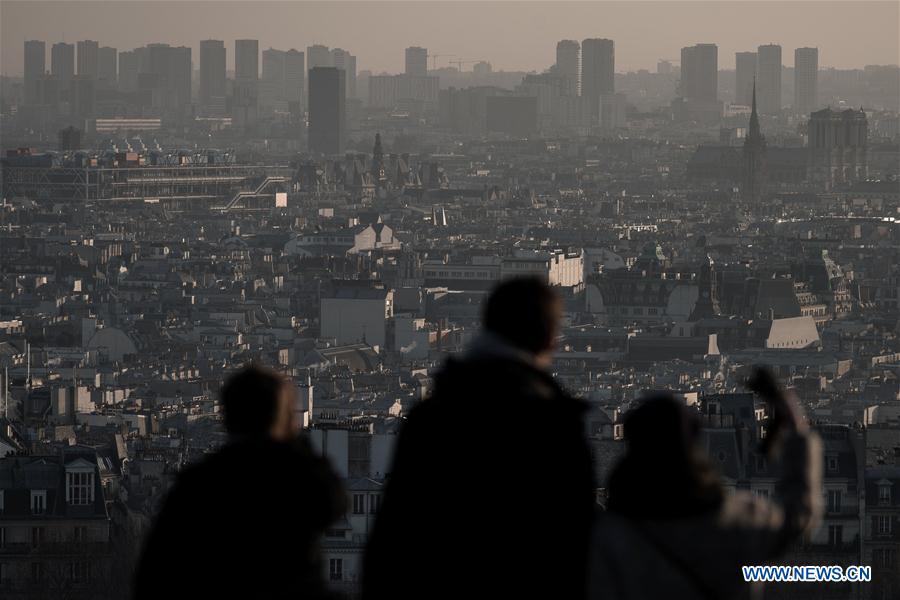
[309,67,347,154]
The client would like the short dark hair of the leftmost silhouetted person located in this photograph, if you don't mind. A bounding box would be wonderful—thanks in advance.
[221,365,284,435]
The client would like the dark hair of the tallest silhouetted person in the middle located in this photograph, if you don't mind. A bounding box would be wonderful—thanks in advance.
[484,277,560,354]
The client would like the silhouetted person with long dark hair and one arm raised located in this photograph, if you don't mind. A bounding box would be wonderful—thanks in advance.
[589,370,822,600]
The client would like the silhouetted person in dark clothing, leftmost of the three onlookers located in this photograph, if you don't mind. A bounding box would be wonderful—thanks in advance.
[134,367,346,600]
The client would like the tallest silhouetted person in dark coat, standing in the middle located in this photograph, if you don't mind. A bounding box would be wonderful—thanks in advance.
[363,278,594,600]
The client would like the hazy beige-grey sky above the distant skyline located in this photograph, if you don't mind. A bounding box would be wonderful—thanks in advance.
[0,0,900,75]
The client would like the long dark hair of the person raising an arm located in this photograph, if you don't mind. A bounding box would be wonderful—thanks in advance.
[608,392,724,519]
